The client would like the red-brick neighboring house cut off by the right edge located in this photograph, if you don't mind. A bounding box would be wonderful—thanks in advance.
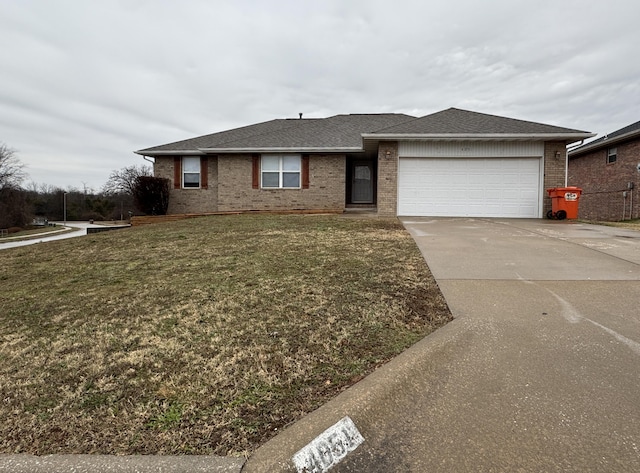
[568,121,640,221]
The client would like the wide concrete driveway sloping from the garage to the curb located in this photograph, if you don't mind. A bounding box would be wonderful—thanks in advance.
[243,218,640,472]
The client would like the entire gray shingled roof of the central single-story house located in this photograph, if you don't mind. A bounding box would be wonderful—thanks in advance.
[136,108,593,156]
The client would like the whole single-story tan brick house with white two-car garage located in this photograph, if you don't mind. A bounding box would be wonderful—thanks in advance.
[136,108,593,218]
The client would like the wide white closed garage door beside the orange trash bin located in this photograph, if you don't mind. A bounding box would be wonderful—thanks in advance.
[398,158,541,218]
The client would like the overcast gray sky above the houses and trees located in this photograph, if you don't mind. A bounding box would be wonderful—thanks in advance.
[0,0,640,190]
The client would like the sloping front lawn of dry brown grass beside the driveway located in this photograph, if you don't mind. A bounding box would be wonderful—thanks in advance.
[0,215,450,455]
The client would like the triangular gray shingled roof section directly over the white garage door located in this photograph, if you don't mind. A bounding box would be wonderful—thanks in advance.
[364,108,587,135]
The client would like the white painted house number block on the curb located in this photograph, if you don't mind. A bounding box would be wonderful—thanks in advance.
[292,417,364,473]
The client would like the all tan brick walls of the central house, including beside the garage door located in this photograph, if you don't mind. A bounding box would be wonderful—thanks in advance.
[154,141,566,216]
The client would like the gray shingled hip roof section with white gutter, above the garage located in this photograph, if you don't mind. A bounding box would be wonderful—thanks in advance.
[364,108,594,141]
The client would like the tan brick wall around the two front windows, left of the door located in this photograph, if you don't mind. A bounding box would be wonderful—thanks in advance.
[154,154,346,214]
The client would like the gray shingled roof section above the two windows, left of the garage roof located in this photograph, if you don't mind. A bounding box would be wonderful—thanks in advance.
[136,113,415,156]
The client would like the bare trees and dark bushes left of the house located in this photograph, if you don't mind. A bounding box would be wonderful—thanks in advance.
[0,143,169,229]
